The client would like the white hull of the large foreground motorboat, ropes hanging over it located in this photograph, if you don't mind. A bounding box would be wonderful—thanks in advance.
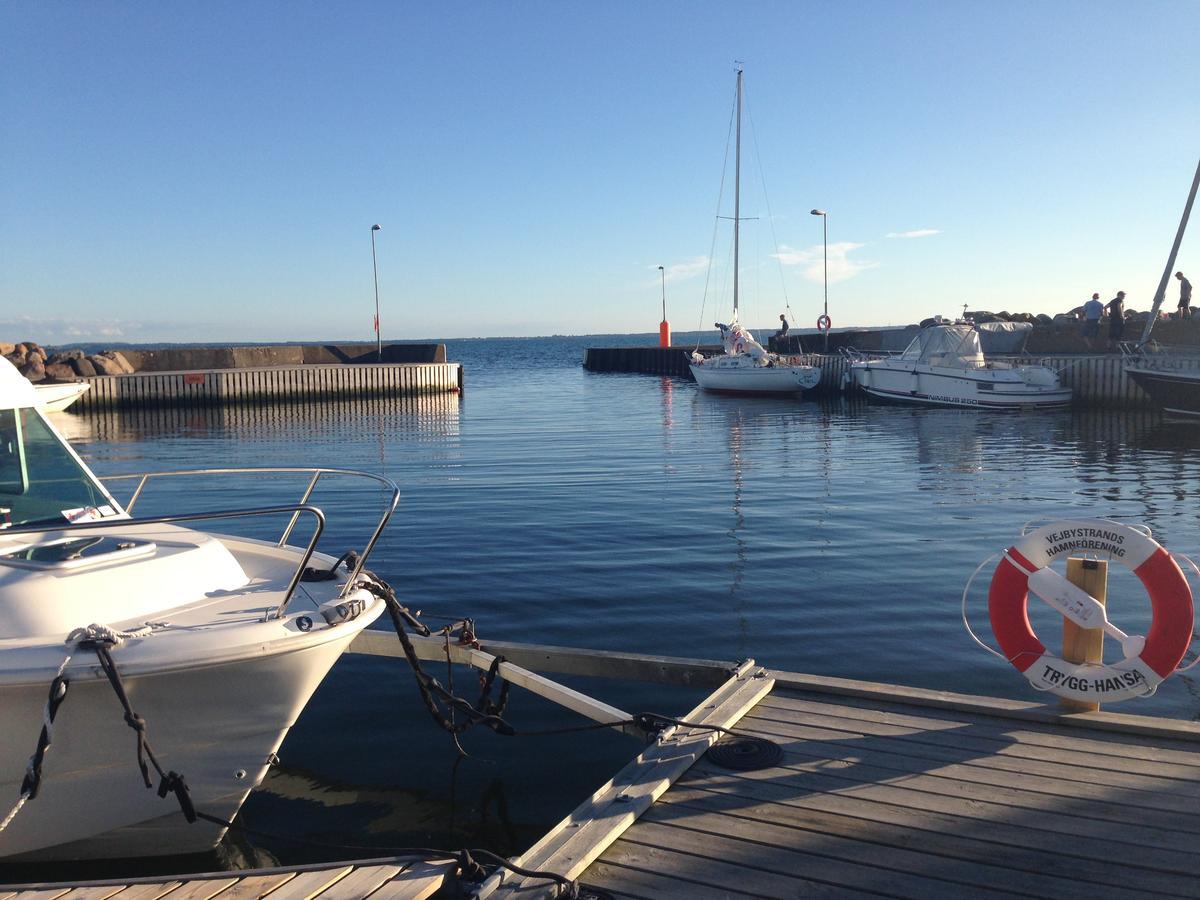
[0,604,382,860]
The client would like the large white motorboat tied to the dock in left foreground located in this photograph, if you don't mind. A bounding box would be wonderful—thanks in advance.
[0,361,398,860]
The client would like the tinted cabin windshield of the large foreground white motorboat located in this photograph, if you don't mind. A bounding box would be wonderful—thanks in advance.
[0,408,119,528]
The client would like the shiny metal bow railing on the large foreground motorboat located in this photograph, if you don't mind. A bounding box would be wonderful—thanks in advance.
[4,467,400,618]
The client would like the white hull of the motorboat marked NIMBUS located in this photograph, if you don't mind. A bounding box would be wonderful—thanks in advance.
[851,360,1072,409]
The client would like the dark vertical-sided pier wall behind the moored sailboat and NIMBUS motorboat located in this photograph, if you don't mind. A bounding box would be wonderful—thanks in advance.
[583,347,1153,409]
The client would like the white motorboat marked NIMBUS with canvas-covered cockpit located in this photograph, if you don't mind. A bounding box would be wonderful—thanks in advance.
[850,322,1072,409]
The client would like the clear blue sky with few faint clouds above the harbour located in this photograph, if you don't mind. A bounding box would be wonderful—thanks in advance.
[0,0,1200,343]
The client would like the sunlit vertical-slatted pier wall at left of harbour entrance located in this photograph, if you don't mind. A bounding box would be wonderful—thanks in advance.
[72,362,463,412]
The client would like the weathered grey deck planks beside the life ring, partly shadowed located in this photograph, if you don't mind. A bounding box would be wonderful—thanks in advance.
[582,673,1200,899]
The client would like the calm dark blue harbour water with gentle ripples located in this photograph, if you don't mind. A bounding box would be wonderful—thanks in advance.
[9,337,1200,872]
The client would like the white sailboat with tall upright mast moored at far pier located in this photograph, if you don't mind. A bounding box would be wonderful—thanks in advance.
[689,68,821,394]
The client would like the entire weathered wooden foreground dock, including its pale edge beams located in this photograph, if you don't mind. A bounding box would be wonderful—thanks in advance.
[9,632,1200,900]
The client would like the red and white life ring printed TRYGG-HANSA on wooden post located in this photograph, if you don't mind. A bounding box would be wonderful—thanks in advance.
[988,518,1193,702]
